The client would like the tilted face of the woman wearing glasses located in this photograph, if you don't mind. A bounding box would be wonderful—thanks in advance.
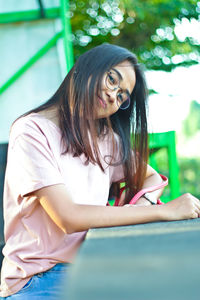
[96,61,136,119]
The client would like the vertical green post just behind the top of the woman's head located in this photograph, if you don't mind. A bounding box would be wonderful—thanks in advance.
[60,0,74,72]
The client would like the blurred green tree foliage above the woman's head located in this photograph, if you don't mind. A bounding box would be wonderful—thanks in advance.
[70,0,200,71]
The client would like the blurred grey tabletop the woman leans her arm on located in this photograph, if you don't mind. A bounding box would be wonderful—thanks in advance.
[63,219,200,300]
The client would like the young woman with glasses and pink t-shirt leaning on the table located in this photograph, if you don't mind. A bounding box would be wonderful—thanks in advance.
[1,44,200,300]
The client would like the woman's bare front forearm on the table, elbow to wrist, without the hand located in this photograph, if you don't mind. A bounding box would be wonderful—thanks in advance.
[66,204,162,233]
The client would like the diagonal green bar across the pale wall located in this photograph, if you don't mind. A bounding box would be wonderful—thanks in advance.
[0,32,62,94]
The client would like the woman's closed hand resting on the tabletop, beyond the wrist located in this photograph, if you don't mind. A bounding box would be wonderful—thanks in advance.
[160,193,200,221]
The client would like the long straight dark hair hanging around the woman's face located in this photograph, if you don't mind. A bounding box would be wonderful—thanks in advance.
[19,44,148,204]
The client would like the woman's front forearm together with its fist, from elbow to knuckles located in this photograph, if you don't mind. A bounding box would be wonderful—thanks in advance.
[67,194,200,232]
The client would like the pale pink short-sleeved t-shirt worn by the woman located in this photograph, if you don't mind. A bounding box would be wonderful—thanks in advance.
[0,113,123,297]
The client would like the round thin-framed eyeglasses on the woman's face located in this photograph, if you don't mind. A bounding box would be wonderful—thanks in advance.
[105,70,130,109]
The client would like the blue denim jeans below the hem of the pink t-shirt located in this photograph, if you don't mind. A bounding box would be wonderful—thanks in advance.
[0,263,70,300]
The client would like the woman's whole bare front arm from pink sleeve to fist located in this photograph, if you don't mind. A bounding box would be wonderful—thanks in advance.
[26,184,200,233]
